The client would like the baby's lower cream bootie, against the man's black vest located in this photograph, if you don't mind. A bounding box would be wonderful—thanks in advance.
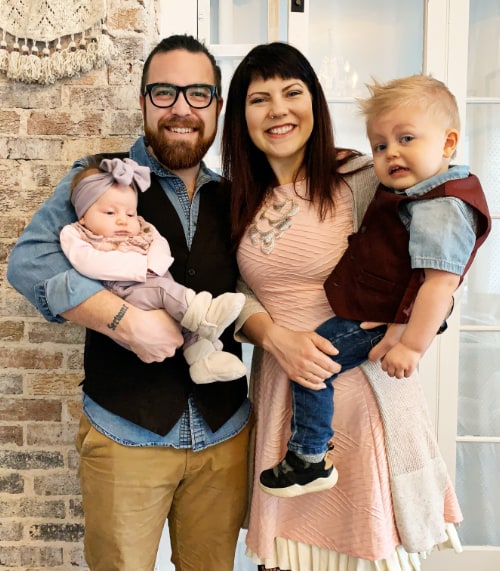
[184,338,247,384]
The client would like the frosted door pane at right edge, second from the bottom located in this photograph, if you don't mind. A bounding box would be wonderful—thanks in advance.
[457,331,500,437]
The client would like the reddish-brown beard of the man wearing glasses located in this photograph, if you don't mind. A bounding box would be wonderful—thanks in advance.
[144,118,216,171]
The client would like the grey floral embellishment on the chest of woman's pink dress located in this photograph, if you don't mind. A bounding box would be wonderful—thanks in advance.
[248,181,305,254]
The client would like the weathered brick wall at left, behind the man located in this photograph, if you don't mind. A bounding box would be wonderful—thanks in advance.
[0,0,158,571]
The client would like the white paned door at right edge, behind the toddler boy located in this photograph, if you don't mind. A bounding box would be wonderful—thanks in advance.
[424,0,500,571]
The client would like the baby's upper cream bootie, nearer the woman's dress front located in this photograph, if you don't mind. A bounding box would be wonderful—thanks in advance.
[181,290,245,341]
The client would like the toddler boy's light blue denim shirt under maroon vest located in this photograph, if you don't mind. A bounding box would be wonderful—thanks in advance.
[400,165,477,275]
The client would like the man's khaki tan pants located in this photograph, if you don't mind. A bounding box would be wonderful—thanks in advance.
[77,415,250,571]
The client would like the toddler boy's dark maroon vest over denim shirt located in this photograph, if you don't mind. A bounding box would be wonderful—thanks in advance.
[325,174,491,323]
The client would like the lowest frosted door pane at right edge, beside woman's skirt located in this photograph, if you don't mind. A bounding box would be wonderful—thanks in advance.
[456,442,500,546]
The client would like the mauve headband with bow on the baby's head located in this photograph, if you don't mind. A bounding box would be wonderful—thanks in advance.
[71,159,151,219]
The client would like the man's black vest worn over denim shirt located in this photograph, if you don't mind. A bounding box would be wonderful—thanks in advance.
[82,154,247,435]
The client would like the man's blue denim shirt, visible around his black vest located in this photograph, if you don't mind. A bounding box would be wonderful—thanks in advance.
[7,137,250,450]
